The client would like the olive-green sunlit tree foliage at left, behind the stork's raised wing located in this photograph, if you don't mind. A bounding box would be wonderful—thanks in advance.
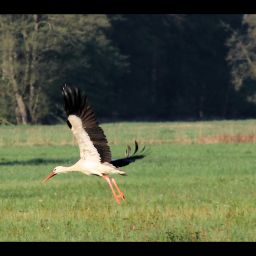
[0,15,126,123]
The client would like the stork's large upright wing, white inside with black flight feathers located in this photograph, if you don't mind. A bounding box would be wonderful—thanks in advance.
[62,85,111,162]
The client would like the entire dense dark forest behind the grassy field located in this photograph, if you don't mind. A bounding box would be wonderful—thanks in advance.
[0,14,256,124]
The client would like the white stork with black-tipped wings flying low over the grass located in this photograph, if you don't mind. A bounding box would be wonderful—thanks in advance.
[44,85,145,204]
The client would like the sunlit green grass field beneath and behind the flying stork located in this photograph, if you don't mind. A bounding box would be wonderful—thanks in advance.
[0,120,256,241]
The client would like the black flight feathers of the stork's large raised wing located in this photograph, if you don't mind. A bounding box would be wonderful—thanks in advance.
[62,85,111,162]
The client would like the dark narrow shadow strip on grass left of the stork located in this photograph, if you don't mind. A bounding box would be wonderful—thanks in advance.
[0,158,75,166]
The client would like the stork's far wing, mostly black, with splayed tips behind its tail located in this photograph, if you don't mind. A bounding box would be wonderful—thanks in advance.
[110,140,146,167]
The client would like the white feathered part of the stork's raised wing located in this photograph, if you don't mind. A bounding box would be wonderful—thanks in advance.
[68,115,101,162]
